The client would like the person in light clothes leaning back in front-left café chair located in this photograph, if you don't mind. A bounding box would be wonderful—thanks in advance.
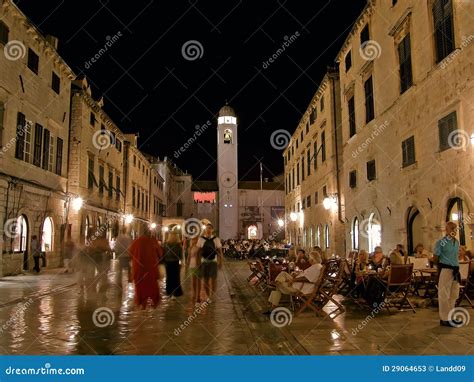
[263,251,323,315]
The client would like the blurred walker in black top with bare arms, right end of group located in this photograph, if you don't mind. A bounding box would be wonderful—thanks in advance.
[197,223,223,299]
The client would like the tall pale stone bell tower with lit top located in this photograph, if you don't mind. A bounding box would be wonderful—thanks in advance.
[217,105,239,240]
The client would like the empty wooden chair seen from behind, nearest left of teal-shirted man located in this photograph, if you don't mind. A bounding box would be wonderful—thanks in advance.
[382,263,416,313]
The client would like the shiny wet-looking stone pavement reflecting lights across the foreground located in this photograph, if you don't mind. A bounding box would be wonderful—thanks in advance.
[0,261,474,355]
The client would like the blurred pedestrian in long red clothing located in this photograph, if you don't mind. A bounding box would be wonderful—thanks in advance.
[129,226,160,309]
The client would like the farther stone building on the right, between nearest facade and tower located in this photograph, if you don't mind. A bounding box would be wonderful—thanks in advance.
[283,70,345,255]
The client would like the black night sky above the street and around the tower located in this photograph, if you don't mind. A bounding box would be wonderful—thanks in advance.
[17,0,366,180]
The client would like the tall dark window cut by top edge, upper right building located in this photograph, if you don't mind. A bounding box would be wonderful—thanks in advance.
[433,0,454,63]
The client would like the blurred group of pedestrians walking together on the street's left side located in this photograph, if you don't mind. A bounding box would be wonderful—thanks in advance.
[44,221,223,309]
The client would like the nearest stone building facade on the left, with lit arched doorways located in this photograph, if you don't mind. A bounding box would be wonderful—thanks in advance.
[0,0,75,275]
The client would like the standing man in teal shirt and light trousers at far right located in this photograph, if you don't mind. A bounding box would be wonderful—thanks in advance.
[434,222,462,327]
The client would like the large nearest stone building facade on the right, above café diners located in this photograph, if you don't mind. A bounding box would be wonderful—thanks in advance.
[337,0,474,252]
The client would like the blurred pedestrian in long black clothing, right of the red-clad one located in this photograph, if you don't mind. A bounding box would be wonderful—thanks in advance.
[163,232,183,300]
